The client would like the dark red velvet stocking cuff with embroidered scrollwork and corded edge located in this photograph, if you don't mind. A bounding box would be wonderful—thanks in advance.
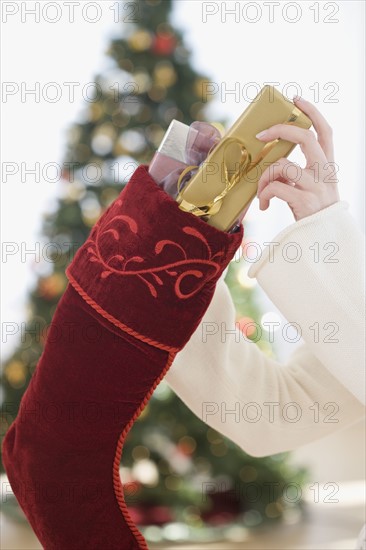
[66,165,243,351]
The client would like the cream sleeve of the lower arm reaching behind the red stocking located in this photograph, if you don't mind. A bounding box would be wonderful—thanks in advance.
[165,202,364,456]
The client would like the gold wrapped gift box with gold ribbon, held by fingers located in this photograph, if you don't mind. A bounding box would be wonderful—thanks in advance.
[177,86,312,231]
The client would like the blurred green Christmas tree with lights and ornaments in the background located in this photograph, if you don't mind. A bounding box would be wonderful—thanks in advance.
[2,0,303,540]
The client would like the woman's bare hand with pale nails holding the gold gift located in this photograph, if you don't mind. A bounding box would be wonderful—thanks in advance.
[256,98,340,221]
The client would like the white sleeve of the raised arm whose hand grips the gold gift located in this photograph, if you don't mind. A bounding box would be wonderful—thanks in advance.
[249,201,366,404]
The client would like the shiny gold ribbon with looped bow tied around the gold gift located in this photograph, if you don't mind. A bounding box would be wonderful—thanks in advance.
[177,107,301,217]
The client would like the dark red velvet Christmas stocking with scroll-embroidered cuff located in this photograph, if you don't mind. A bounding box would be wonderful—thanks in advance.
[2,165,243,550]
